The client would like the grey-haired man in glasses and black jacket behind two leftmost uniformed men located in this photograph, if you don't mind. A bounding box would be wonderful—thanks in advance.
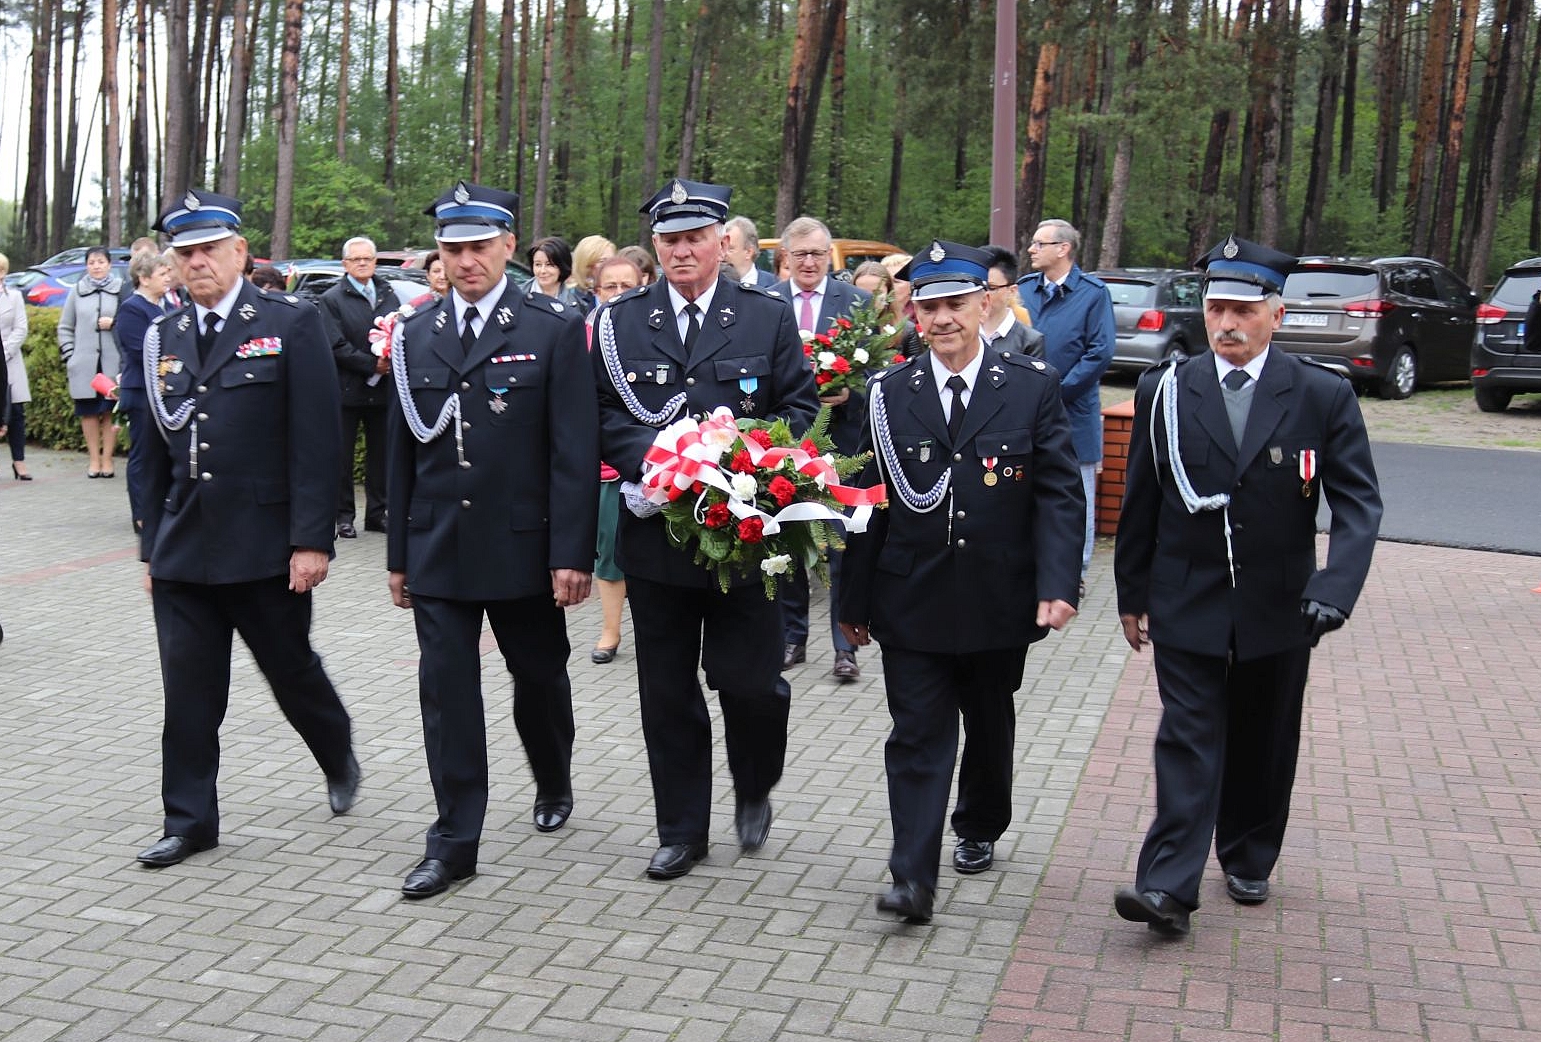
[316,236,401,539]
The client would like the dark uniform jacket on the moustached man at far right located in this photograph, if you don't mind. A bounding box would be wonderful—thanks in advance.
[1114,348,1381,660]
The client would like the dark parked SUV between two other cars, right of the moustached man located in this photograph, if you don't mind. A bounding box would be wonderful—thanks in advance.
[1273,257,1481,398]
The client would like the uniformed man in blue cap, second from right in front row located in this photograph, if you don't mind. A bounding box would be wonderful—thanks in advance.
[840,242,1086,923]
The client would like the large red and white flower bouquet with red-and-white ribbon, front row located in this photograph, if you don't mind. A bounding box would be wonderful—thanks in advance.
[643,407,885,598]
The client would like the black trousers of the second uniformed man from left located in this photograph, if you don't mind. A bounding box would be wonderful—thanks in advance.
[411,593,573,868]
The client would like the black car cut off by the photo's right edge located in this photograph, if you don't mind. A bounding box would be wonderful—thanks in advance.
[1472,257,1541,413]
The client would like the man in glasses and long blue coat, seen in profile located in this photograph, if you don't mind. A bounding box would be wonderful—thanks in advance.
[1017,219,1117,594]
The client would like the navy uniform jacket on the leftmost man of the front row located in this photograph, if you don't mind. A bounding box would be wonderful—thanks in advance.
[140,282,342,584]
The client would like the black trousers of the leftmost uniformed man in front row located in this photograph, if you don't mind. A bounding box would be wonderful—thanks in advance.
[151,576,353,842]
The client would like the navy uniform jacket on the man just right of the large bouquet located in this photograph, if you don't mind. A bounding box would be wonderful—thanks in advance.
[840,347,1086,654]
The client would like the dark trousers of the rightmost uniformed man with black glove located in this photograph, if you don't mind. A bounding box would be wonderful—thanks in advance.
[1134,644,1311,909]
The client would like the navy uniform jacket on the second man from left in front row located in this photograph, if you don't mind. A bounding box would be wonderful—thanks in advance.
[387,282,599,601]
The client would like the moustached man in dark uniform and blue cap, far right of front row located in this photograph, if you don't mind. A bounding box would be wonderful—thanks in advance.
[1114,236,1381,937]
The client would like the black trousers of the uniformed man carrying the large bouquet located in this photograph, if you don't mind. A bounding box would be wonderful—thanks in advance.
[626,575,792,846]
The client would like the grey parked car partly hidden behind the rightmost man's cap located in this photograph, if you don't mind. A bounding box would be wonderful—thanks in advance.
[1093,268,1210,373]
